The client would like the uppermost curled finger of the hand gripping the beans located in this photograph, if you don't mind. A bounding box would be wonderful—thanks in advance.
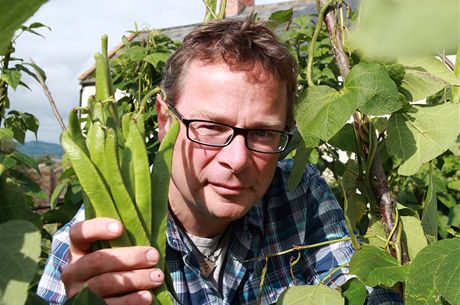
[69,217,123,255]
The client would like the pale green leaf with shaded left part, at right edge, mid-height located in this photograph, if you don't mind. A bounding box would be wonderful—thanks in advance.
[387,103,460,176]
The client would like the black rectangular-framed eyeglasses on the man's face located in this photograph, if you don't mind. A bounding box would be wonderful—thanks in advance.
[167,103,292,154]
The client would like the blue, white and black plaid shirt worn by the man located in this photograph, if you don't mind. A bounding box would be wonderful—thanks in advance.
[37,160,402,305]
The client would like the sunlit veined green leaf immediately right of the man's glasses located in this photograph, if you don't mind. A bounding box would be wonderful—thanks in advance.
[295,86,358,144]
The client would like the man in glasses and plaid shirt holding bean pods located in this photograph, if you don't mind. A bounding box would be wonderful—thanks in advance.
[38,18,399,305]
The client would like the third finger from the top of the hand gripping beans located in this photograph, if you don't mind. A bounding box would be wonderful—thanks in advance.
[88,268,164,298]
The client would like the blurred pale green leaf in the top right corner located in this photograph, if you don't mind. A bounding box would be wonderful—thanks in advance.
[347,0,460,58]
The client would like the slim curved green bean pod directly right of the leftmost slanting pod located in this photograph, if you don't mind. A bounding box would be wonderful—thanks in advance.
[105,128,150,246]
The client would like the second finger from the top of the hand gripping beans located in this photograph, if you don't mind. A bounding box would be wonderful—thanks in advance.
[63,246,160,283]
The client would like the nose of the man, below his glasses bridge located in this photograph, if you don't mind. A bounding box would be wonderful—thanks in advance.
[218,134,251,173]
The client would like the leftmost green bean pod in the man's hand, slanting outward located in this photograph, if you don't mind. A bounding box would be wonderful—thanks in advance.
[61,131,131,247]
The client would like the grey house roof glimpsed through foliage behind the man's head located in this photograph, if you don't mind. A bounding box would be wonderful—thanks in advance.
[78,0,348,86]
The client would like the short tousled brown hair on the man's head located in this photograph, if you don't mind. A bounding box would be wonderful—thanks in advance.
[162,16,297,127]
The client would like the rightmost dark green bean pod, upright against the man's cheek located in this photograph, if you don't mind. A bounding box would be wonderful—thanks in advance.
[151,120,179,304]
